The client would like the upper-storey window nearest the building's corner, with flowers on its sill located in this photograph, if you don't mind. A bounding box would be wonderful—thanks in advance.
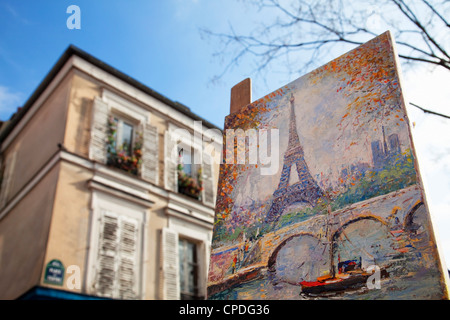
[107,116,142,175]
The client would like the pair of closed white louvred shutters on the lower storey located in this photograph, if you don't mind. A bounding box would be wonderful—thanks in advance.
[95,210,140,299]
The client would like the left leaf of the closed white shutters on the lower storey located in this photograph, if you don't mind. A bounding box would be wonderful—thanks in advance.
[96,211,119,298]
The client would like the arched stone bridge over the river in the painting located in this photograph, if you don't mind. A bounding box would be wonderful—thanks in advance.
[208,185,425,294]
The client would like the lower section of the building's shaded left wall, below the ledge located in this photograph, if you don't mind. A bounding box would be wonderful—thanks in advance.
[0,165,59,300]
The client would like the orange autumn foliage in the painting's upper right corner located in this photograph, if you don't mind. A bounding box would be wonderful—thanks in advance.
[309,33,407,149]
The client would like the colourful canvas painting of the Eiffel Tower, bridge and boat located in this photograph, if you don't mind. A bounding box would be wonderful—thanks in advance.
[208,32,448,300]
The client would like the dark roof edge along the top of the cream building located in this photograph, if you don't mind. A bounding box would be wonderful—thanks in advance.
[0,45,222,142]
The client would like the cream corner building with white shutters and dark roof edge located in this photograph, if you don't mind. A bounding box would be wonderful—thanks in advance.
[0,46,222,299]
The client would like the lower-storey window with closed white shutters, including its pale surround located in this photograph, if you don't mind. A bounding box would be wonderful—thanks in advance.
[87,191,145,300]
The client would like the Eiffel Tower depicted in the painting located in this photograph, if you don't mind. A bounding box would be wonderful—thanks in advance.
[266,95,323,223]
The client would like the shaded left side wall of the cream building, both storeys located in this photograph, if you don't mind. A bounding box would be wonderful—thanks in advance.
[0,70,71,299]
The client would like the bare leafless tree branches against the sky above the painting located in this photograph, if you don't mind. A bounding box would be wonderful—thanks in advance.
[202,0,450,78]
